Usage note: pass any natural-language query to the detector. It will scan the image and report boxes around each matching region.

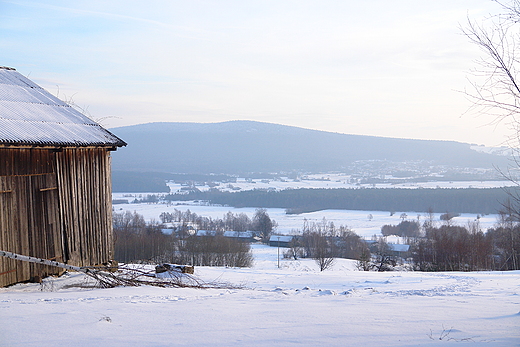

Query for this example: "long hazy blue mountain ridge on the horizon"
[111,121,507,174]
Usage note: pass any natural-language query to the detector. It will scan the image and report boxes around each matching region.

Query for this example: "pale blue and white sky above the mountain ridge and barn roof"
[0,0,507,146]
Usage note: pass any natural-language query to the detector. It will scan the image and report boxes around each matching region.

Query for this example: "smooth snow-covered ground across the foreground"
[0,245,520,347]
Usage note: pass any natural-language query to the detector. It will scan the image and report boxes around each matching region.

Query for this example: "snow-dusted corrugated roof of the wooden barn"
[0,67,126,147]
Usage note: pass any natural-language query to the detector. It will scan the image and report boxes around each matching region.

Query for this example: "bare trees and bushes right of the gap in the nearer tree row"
[284,212,520,271]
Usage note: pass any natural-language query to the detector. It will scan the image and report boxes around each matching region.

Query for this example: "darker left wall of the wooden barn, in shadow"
[0,149,63,286]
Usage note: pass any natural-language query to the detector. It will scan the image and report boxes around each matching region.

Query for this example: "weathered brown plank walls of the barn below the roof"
[0,148,113,286]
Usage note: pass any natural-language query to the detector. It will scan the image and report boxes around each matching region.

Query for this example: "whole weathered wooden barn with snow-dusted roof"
[0,67,126,287]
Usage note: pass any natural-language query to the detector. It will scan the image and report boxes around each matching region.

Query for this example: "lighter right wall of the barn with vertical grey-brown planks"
[56,148,114,266]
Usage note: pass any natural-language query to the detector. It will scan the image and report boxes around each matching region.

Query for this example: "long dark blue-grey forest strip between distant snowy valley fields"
[165,188,508,214]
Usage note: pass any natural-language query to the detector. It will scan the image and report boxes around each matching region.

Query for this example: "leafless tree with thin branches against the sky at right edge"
[463,0,520,269]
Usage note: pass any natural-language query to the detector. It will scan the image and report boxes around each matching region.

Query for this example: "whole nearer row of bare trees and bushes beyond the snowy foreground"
[114,209,520,271]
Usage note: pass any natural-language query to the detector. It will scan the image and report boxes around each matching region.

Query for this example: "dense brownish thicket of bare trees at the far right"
[379,212,520,271]
